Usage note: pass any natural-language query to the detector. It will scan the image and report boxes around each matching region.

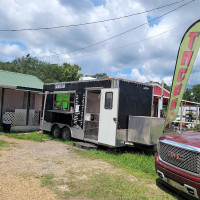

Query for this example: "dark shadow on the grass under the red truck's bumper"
[156,178,197,200]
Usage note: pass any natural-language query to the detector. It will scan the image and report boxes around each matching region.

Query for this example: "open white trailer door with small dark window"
[98,88,119,146]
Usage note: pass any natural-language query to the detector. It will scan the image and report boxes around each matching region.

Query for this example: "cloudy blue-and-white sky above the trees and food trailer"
[0,0,200,85]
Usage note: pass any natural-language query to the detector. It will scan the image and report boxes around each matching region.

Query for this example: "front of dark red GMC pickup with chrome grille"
[155,132,200,198]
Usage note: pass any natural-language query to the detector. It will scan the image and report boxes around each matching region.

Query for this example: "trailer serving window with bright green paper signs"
[54,93,74,110]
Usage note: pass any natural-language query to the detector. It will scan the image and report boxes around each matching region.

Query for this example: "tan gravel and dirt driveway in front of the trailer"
[0,135,138,200]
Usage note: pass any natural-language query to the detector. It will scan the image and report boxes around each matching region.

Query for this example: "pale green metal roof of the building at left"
[0,70,43,89]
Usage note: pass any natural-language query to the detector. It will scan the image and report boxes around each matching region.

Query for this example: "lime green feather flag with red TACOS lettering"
[165,20,200,126]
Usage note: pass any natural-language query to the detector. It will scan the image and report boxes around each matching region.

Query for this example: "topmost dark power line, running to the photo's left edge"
[0,0,185,32]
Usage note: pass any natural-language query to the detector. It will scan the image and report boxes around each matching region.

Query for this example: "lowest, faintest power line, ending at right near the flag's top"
[46,17,199,60]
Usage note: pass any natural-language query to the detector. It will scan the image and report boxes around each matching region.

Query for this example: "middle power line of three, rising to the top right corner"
[37,0,195,58]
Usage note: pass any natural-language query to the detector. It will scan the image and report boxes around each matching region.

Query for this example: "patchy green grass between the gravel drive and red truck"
[70,150,182,200]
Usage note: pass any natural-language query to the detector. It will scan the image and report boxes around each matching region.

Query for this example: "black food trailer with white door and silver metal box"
[43,79,164,147]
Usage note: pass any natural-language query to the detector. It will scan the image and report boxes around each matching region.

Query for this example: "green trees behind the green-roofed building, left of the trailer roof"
[0,57,82,83]
